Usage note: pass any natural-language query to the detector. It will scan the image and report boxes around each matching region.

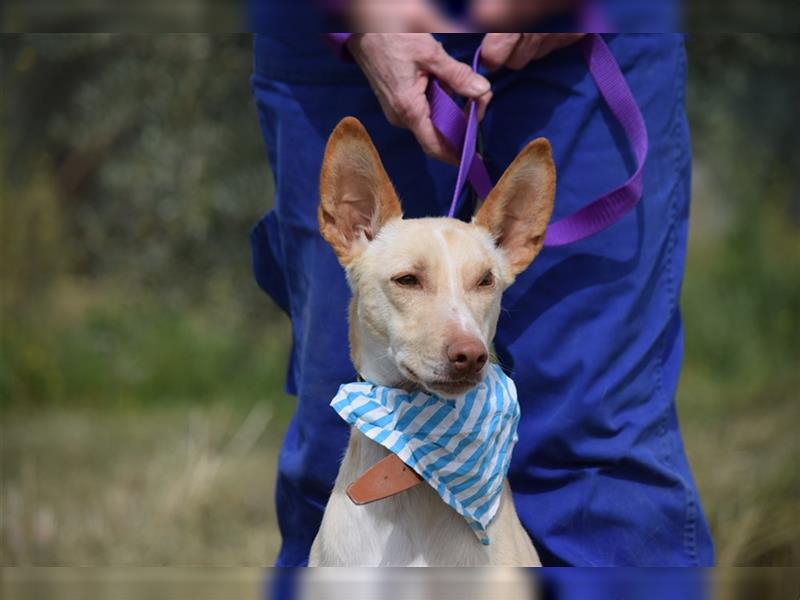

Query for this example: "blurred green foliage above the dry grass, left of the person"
[0,35,287,414]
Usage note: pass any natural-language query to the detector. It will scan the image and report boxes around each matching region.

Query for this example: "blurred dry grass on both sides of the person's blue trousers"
[0,392,800,566]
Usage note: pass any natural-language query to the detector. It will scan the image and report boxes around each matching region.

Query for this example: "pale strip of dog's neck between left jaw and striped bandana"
[349,294,417,391]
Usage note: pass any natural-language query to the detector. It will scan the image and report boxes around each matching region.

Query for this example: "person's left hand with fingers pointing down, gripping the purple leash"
[347,33,492,164]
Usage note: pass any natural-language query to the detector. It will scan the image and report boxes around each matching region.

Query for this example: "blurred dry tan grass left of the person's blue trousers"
[0,404,279,566]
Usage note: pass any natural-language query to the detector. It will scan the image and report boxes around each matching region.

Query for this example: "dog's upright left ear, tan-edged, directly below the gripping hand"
[317,117,402,266]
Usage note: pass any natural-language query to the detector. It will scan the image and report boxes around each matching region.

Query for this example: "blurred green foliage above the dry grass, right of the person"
[682,34,800,409]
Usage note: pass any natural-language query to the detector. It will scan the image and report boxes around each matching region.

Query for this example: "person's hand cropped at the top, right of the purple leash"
[481,33,584,71]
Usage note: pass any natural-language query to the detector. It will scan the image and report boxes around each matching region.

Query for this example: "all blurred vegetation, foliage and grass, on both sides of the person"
[0,35,800,565]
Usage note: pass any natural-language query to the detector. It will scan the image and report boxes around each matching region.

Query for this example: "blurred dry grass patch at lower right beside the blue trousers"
[681,394,800,566]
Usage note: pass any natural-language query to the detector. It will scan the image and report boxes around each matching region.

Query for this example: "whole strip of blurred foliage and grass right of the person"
[678,34,800,565]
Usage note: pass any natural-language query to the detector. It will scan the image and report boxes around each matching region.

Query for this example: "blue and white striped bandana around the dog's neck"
[331,364,519,544]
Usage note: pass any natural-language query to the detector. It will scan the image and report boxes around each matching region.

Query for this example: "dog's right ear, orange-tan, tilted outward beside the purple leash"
[473,138,556,275]
